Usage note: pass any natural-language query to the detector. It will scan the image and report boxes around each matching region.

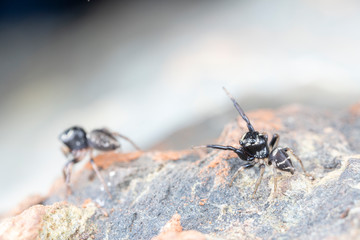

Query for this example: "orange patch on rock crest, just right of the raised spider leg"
[249,109,283,132]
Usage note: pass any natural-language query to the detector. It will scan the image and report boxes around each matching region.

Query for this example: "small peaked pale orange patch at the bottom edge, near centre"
[152,213,206,240]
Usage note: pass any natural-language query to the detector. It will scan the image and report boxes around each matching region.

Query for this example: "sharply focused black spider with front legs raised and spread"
[201,88,312,197]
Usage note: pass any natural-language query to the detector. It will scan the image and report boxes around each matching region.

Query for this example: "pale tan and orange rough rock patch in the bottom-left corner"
[0,201,96,240]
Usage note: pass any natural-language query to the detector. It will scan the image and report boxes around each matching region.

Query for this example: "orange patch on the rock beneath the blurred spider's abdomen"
[85,151,143,169]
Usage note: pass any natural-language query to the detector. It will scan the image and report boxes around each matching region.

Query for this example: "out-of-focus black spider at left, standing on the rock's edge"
[59,126,140,198]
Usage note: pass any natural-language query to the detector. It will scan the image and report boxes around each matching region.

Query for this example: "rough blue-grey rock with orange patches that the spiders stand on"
[0,105,360,239]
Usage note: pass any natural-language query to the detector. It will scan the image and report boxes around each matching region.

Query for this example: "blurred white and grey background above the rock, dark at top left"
[0,0,360,212]
